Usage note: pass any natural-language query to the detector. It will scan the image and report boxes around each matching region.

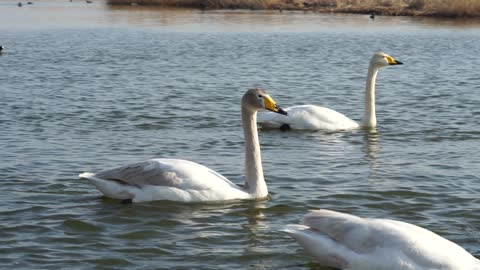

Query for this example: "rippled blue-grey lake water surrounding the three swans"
[0,1,480,269]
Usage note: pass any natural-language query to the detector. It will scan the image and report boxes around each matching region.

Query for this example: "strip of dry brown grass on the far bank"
[107,0,480,17]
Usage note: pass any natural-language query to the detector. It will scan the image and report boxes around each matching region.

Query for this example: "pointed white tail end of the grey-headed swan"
[78,172,132,200]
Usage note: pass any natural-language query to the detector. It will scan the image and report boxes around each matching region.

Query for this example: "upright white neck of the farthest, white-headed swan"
[362,64,378,128]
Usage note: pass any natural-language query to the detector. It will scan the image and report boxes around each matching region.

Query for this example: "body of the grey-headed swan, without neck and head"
[80,158,253,202]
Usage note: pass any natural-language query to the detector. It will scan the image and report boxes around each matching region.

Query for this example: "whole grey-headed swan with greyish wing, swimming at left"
[79,89,286,202]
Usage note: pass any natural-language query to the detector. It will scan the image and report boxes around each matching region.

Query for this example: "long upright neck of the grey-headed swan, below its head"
[242,107,268,198]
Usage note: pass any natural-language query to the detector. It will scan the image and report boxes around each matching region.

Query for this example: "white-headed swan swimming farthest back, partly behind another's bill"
[258,52,403,131]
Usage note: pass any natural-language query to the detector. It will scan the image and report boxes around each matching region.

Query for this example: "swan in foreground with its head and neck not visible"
[284,210,480,270]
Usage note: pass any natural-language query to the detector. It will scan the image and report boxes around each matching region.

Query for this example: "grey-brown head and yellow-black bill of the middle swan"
[242,88,287,115]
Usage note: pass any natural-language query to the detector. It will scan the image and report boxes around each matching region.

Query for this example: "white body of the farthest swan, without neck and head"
[258,105,359,131]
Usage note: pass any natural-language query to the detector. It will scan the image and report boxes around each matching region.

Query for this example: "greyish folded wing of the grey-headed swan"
[95,159,233,190]
